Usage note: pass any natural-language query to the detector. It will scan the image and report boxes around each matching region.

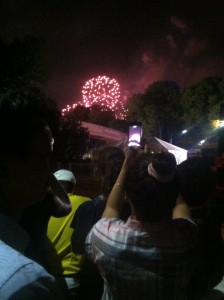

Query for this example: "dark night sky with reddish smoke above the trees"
[0,0,224,108]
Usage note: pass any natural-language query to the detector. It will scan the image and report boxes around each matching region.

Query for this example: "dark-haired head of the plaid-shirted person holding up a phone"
[124,152,179,222]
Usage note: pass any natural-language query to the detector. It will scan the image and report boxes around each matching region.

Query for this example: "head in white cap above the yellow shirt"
[54,169,76,194]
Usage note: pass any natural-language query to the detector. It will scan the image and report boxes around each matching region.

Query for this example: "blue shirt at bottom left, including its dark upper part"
[0,213,65,300]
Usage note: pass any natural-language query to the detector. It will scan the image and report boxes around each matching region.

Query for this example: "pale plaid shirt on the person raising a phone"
[86,218,197,300]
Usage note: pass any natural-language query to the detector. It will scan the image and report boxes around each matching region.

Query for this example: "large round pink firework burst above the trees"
[82,76,124,119]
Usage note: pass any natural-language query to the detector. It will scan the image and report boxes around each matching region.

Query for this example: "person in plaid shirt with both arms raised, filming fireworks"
[86,148,197,300]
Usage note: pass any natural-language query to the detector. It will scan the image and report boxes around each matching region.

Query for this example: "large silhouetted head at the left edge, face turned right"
[0,90,60,218]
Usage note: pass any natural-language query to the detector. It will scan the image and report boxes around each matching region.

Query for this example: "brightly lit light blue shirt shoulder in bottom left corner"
[0,241,64,299]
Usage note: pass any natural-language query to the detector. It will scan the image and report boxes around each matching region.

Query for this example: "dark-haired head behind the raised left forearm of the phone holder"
[94,146,125,198]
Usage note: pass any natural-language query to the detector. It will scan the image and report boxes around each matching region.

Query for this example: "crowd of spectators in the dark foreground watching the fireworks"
[0,92,224,300]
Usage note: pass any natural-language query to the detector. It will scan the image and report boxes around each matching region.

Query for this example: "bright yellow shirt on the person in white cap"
[47,194,90,276]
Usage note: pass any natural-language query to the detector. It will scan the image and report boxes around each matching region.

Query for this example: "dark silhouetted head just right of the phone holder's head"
[177,156,215,207]
